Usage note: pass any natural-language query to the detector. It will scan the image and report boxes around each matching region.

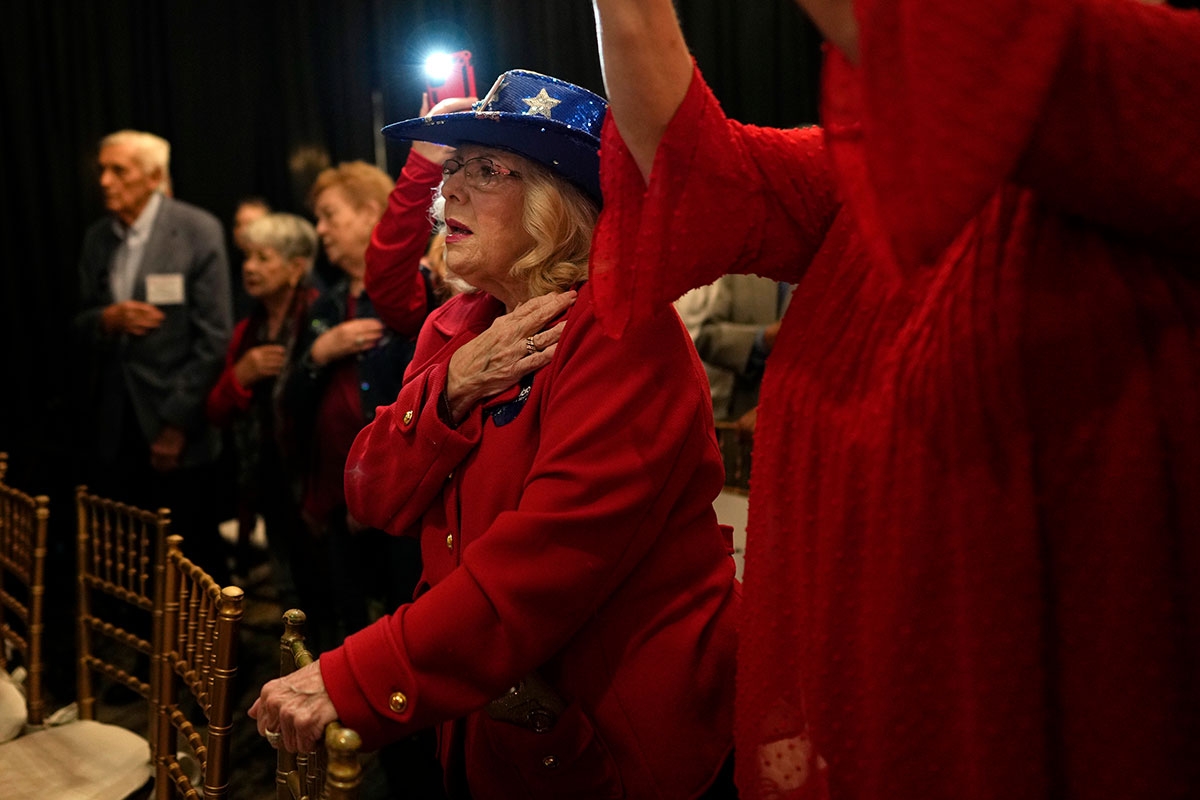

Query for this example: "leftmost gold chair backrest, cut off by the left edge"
[0,453,50,726]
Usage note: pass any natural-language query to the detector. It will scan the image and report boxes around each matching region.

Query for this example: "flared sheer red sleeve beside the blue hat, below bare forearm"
[589,63,838,336]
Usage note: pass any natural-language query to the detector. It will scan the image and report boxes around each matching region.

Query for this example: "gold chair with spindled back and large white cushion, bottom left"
[0,487,157,800]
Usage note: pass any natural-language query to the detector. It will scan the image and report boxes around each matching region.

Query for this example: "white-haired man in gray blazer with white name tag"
[74,131,233,575]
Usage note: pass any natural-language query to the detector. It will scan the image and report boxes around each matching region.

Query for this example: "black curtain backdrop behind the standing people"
[0,0,820,494]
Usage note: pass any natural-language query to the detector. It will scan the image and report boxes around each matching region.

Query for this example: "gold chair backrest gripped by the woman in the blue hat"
[275,608,362,800]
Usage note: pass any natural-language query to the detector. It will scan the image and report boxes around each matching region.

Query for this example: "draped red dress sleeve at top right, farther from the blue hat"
[822,0,1200,266]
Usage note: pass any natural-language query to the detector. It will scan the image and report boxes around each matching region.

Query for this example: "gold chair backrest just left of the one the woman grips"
[155,535,245,800]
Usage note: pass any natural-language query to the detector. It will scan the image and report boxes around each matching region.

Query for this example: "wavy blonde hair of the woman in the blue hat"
[431,154,600,297]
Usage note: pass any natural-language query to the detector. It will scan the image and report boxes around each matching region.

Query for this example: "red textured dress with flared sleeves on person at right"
[592,0,1200,800]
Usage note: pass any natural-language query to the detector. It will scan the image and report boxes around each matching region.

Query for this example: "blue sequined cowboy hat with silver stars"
[383,70,608,204]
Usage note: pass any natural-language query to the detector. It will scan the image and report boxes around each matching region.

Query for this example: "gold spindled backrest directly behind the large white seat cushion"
[76,486,170,734]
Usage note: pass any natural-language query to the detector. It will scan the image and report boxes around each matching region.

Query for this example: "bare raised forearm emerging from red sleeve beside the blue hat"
[593,0,692,178]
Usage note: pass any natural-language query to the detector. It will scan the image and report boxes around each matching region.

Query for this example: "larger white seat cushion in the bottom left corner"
[0,720,152,800]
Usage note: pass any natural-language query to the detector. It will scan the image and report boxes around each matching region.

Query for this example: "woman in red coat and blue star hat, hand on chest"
[251,71,739,800]
